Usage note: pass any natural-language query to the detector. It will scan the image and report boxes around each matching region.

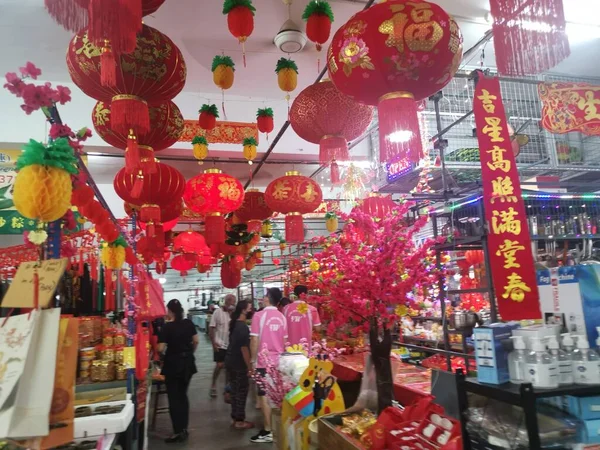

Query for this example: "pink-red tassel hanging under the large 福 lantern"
[377,92,423,162]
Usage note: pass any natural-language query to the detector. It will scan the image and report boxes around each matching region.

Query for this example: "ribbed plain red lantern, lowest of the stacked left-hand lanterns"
[113,163,185,237]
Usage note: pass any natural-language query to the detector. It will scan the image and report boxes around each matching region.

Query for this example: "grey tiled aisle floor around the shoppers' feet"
[148,335,262,450]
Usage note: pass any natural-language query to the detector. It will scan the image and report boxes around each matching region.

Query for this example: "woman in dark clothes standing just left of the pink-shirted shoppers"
[225,300,254,430]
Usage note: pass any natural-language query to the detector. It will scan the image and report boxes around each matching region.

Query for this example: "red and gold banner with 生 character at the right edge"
[538,83,600,136]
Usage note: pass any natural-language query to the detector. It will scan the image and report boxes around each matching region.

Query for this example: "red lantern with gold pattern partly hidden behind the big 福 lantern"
[290,80,373,179]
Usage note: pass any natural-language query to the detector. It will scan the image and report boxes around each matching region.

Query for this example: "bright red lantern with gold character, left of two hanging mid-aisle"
[183,169,244,246]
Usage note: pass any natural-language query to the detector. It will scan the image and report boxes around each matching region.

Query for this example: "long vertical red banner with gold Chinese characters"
[473,72,542,321]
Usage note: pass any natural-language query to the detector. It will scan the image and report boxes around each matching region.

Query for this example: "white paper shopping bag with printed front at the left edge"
[0,308,60,440]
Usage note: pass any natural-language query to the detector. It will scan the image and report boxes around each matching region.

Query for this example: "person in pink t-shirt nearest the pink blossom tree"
[283,285,321,350]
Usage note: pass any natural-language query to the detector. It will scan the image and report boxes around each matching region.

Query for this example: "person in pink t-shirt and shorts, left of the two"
[250,288,288,443]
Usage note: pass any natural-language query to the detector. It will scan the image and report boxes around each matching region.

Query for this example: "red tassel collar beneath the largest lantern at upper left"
[110,95,150,138]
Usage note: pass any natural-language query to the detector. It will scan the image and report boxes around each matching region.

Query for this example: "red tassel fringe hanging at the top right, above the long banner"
[490,0,571,76]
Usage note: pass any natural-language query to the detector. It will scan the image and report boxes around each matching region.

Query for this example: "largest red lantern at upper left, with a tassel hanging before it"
[67,25,186,141]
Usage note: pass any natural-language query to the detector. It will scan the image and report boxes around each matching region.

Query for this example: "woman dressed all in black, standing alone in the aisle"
[158,299,198,443]
